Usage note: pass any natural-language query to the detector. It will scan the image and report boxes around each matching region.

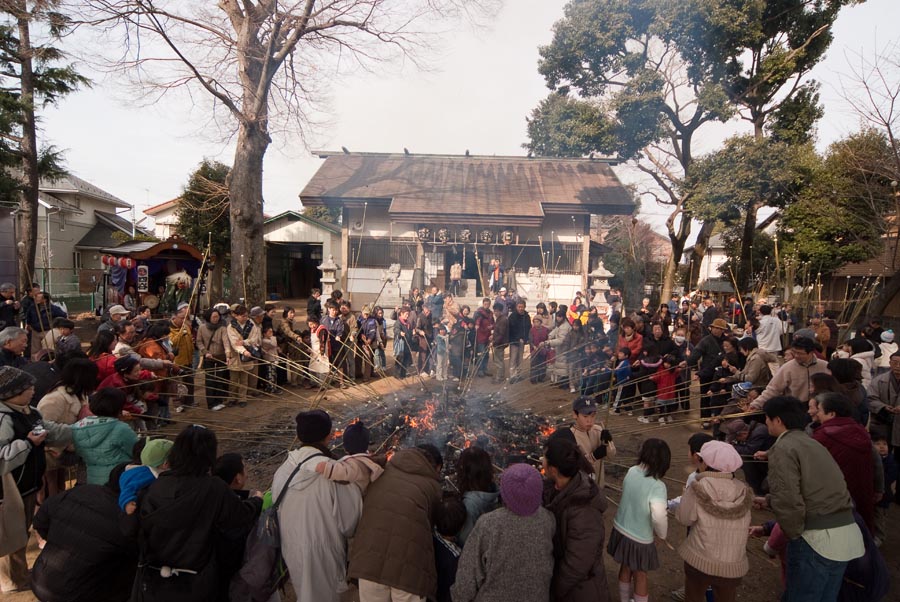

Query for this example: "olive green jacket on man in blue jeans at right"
[767,430,855,539]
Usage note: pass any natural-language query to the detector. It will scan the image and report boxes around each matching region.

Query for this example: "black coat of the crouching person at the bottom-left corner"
[31,485,138,602]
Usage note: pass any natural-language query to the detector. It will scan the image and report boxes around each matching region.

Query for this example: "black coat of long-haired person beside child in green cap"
[132,472,262,602]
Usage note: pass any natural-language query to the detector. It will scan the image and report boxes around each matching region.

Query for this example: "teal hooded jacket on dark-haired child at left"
[72,416,138,485]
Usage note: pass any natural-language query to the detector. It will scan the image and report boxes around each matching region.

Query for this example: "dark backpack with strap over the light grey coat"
[229,454,325,602]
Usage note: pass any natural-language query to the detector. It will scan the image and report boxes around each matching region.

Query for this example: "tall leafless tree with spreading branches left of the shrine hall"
[77,0,500,302]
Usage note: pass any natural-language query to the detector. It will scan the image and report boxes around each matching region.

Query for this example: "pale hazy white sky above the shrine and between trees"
[40,0,900,232]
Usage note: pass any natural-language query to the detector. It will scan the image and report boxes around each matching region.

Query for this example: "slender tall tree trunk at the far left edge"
[16,0,39,291]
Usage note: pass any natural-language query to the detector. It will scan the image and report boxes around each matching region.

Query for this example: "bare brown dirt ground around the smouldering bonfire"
[0,314,900,602]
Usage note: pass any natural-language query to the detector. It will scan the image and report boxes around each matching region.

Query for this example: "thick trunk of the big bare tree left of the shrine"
[227,122,271,307]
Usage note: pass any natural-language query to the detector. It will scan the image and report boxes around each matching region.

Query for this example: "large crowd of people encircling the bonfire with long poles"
[0,278,900,602]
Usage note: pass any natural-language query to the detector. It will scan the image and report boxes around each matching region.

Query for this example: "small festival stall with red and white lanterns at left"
[100,236,214,314]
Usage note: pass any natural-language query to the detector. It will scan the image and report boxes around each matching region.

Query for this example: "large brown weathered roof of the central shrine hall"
[300,152,635,225]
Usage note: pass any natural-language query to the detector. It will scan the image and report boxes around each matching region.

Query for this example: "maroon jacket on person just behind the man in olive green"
[813,417,875,531]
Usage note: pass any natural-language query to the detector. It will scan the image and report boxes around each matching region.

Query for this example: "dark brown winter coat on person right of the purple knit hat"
[547,472,609,602]
